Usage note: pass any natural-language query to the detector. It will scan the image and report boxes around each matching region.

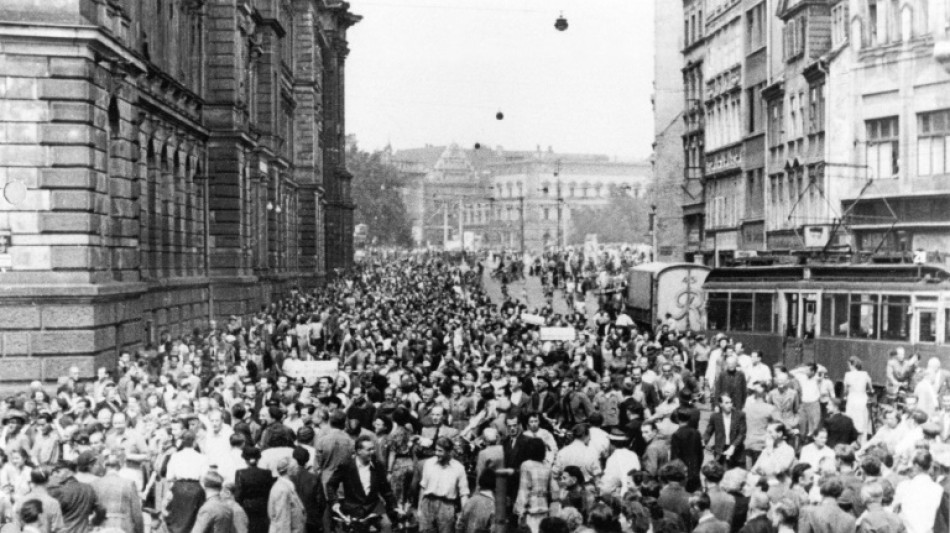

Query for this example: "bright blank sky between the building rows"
[346,0,653,159]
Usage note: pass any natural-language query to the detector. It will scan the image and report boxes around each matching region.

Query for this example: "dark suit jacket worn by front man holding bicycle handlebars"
[327,458,396,518]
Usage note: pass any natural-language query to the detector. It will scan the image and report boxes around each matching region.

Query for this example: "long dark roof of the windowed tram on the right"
[706,263,950,284]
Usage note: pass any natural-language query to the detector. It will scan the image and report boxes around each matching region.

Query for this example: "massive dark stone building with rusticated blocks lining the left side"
[0,0,359,381]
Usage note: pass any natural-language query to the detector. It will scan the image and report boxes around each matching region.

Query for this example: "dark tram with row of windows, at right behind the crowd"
[703,264,950,384]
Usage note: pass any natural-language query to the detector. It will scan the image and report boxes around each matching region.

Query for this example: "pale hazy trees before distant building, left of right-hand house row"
[570,187,650,244]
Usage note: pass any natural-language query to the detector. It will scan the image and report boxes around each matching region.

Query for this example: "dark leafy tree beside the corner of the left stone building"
[346,144,412,246]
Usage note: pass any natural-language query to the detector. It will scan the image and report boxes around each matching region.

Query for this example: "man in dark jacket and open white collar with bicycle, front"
[327,435,399,529]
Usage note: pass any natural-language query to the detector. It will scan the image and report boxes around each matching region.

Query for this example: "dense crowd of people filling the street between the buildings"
[0,254,950,533]
